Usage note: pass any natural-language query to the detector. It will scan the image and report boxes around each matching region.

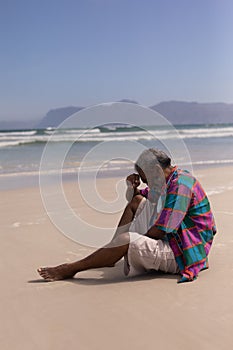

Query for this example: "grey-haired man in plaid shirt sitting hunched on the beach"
[38,149,216,282]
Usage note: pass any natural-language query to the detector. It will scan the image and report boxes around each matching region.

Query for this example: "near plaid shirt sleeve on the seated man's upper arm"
[155,178,193,233]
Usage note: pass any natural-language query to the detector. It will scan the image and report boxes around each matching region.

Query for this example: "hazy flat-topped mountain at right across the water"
[150,101,233,125]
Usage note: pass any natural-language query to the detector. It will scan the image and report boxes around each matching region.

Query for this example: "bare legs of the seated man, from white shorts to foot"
[37,196,143,281]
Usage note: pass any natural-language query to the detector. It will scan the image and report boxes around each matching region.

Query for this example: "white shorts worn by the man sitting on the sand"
[124,198,179,276]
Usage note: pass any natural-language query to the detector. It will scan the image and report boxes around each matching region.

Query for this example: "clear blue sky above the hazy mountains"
[0,0,233,120]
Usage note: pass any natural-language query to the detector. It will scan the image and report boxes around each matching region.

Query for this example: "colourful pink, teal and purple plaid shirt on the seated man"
[155,167,216,282]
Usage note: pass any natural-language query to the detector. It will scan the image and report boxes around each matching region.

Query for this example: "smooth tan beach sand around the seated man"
[0,167,233,350]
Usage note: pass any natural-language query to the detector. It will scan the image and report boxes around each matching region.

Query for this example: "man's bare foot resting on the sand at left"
[37,264,75,282]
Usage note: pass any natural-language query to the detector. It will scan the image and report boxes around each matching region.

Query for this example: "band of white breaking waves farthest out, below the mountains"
[0,125,233,148]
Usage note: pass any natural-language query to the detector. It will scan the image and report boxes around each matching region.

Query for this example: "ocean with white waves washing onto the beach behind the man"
[0,124,233,190]
